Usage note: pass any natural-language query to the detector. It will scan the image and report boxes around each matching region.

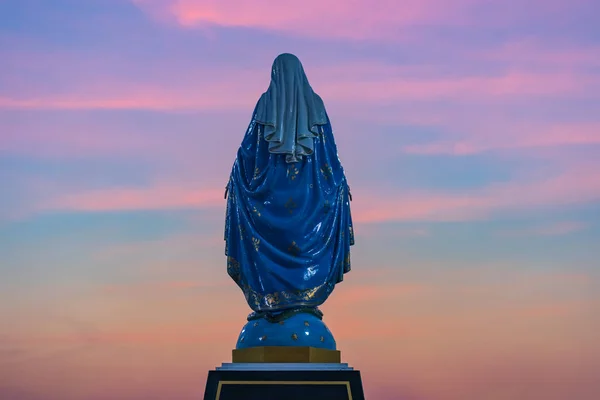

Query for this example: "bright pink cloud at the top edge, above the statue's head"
[132,0,472,39]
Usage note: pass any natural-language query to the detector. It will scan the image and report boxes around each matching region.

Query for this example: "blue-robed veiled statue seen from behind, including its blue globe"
[225,54,354,350]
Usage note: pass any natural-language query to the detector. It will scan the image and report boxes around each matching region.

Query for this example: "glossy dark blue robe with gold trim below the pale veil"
[225,103,354,312]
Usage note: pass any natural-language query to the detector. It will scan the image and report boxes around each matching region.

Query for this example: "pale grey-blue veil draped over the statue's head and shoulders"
[256,53,327,163]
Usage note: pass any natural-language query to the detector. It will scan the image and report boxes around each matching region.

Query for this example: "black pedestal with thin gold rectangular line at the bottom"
[204,369,365,400]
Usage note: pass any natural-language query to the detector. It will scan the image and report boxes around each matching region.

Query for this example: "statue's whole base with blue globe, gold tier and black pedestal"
[204,313,364,400]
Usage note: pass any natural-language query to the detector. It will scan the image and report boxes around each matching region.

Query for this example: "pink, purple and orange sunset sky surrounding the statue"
[0,0,600,400]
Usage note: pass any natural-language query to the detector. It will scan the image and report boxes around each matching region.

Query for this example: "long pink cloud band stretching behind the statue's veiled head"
[0,65,600,111]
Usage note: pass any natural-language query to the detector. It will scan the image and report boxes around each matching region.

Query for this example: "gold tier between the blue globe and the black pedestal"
[232,346,342,363]
